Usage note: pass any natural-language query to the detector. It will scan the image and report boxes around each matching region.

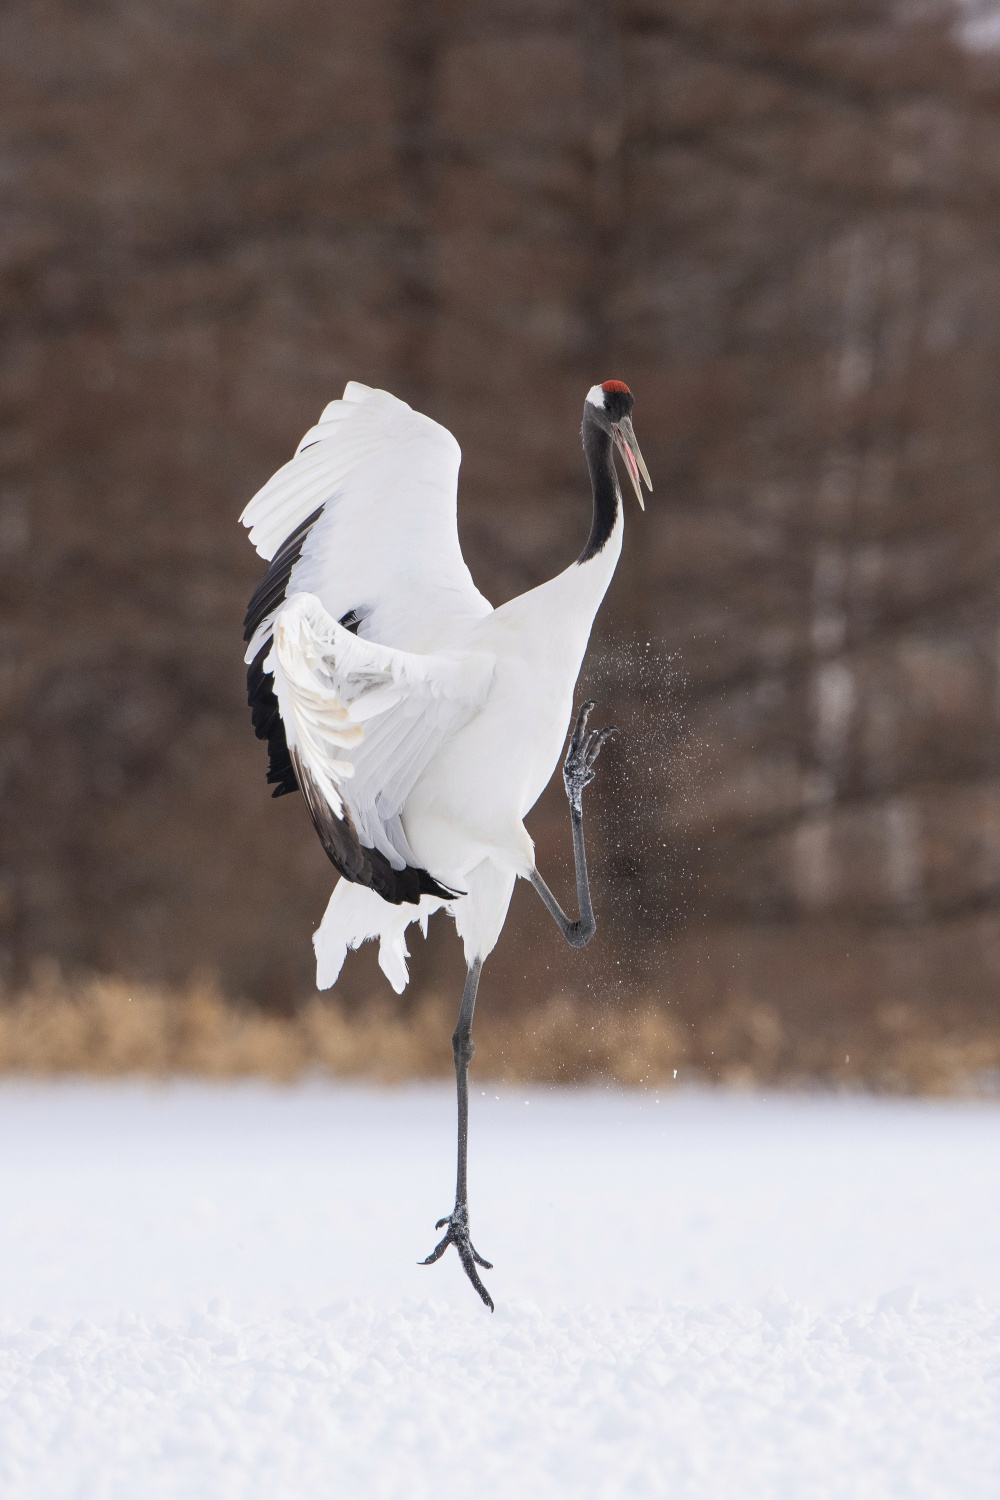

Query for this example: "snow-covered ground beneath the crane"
[0,1085,1000,1500]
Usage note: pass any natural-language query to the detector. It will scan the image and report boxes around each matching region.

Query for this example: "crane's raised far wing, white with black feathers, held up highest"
[241,381,492,816]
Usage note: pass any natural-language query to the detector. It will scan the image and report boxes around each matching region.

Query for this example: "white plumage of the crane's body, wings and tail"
[241,381,622,993]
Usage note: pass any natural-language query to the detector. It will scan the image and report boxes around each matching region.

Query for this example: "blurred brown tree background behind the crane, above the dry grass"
[0,0,1000,1046]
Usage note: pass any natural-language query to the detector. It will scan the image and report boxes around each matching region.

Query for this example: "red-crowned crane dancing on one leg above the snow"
[241,380,652,1310]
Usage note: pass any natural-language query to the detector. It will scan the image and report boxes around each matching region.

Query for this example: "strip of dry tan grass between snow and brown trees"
[0,966,1000,1094]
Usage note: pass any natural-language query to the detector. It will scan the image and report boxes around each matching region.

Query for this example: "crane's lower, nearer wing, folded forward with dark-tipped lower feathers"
[271,593,493,905]
